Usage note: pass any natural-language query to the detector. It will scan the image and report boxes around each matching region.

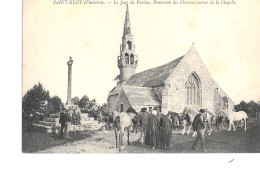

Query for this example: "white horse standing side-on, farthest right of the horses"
[219,109,248,131]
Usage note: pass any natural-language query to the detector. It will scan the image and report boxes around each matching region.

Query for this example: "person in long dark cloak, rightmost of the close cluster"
[161,114,172,150]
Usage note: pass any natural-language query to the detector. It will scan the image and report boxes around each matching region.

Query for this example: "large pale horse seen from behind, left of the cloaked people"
[113,110,137,151]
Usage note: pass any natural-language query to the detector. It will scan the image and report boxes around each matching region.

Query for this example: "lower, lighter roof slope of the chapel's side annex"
[123,86,161,106]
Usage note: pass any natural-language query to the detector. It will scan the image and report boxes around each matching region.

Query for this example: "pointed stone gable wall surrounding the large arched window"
[162,49,217,112]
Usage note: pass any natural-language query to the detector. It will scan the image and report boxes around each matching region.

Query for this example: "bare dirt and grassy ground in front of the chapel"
[22,119,260,153]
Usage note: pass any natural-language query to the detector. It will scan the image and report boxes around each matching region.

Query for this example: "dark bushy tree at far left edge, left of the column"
[22,82,50,115]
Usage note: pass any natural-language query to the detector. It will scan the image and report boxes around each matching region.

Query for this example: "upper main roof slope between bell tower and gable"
[124,56,184,87]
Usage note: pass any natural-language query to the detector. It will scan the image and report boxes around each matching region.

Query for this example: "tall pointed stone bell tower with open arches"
[117,5,138,83]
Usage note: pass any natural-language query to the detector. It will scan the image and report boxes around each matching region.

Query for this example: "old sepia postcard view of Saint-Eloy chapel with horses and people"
[20,0,260,154]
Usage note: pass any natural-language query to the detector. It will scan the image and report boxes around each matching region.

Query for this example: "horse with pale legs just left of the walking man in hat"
[181,107,198,136]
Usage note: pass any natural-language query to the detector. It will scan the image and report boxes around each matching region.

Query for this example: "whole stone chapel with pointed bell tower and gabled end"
[107,6,234,113]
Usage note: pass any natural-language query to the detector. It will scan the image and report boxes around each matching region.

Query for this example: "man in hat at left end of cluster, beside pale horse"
[139,108,149,144]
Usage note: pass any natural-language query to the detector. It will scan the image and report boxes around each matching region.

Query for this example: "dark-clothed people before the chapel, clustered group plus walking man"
[138,108,207,152]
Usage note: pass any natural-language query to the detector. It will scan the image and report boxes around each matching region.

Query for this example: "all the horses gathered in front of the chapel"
[108,107,248,151]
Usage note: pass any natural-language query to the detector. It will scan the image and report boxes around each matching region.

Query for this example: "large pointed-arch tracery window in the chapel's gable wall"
[185,73,202,106]
